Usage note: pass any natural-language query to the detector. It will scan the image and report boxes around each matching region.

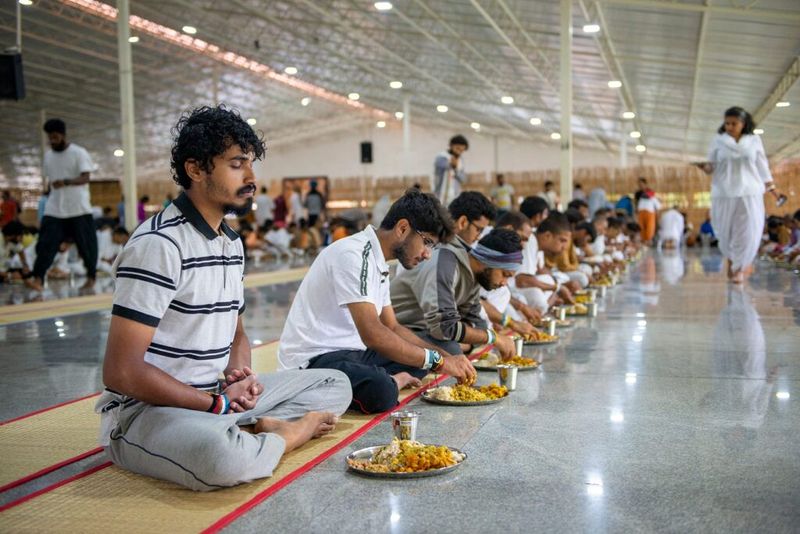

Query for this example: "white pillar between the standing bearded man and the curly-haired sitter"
[117,0,139,232]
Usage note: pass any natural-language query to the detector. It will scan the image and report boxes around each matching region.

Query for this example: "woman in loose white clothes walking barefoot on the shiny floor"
[698,107,780,284]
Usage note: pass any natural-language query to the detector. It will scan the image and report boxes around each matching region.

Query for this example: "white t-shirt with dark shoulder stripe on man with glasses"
[278,226,392,369]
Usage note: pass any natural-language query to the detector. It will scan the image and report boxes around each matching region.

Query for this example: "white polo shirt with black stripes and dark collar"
[112,193,244,388]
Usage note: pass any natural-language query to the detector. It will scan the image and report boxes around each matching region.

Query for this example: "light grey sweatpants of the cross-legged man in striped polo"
[106,369,352,491]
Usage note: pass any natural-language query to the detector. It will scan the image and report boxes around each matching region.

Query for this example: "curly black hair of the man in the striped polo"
[170,105,267,189]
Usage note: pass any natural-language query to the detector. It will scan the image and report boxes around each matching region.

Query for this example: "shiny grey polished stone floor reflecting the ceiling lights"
[0,251,800,532]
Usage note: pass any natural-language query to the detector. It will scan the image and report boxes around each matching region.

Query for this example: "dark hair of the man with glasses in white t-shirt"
[381,187,453,242]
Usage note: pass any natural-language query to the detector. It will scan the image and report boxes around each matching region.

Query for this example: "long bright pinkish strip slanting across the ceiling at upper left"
[63,0,389,118]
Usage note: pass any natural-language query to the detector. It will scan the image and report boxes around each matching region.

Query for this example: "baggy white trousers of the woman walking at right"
[711,195,764,272]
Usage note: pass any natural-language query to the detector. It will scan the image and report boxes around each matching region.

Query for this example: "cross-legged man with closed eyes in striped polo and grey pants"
[97,106,351,491]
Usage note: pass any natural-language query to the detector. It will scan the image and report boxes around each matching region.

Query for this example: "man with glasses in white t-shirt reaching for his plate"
[278,189,475,413]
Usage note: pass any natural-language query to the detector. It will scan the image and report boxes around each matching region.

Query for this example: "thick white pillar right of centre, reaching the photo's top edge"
[559,0,572,205]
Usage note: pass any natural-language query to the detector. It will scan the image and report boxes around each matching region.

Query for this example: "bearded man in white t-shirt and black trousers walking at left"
[25,119,97,291]
